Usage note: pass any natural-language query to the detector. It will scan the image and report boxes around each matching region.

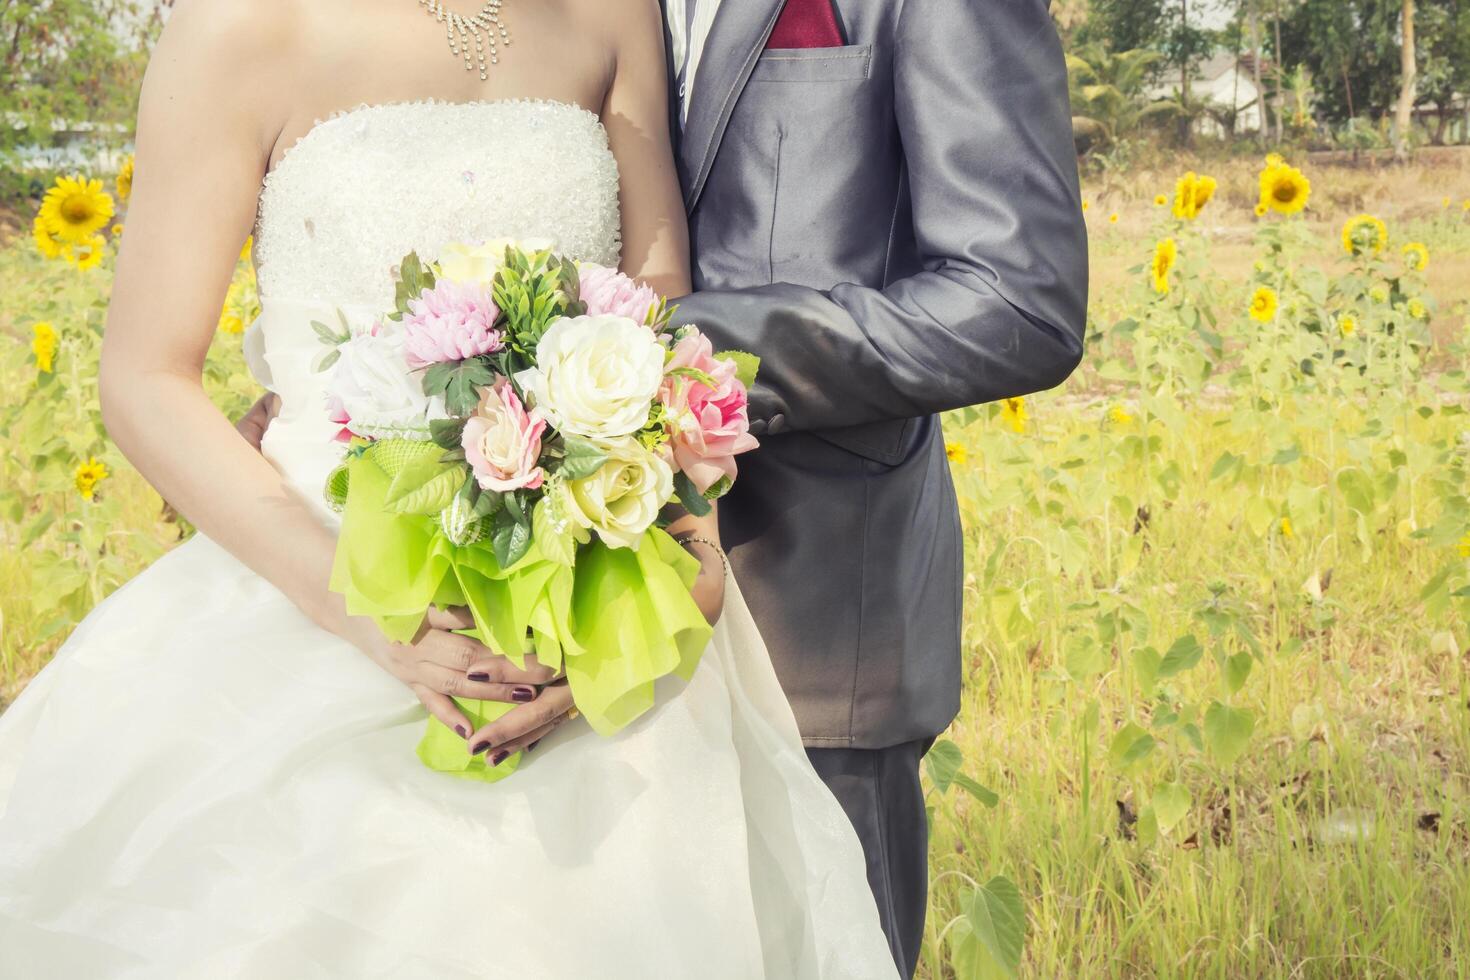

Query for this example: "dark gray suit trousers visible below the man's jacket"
[807,739,933,979]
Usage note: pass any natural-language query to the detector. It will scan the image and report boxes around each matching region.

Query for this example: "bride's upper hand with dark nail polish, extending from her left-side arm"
[348,608,564,738]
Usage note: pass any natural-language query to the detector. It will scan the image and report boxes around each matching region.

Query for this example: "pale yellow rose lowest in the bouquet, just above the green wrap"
[566,436,673,550]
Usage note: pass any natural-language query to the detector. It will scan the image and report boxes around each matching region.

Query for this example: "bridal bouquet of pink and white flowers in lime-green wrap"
[313,242,757,780]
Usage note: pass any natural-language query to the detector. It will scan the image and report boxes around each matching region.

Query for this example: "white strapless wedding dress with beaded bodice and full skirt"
[0,101,895,980]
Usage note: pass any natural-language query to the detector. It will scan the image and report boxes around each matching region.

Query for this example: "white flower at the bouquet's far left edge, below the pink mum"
[326,323,447,439]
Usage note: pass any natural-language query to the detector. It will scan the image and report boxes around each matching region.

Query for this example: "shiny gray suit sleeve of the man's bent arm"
[678,0,1088,432]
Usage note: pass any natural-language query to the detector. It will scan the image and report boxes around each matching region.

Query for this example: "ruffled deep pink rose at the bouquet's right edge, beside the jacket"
[659,331,760,494]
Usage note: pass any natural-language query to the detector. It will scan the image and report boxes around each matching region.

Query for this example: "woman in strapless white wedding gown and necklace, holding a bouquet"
[0,0,894,980]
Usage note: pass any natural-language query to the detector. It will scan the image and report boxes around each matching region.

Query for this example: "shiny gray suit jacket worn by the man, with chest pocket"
[667,0,1088,748]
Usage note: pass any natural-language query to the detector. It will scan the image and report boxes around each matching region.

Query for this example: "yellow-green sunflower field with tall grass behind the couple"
[0,149,1470,980]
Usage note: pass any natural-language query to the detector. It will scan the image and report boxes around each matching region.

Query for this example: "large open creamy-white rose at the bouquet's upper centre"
[516,316,664,439]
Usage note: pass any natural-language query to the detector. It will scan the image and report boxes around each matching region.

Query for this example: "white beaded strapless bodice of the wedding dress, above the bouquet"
[256,100,622,302]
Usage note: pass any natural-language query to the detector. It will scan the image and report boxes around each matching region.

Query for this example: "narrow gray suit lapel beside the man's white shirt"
[669,0,785,212]
